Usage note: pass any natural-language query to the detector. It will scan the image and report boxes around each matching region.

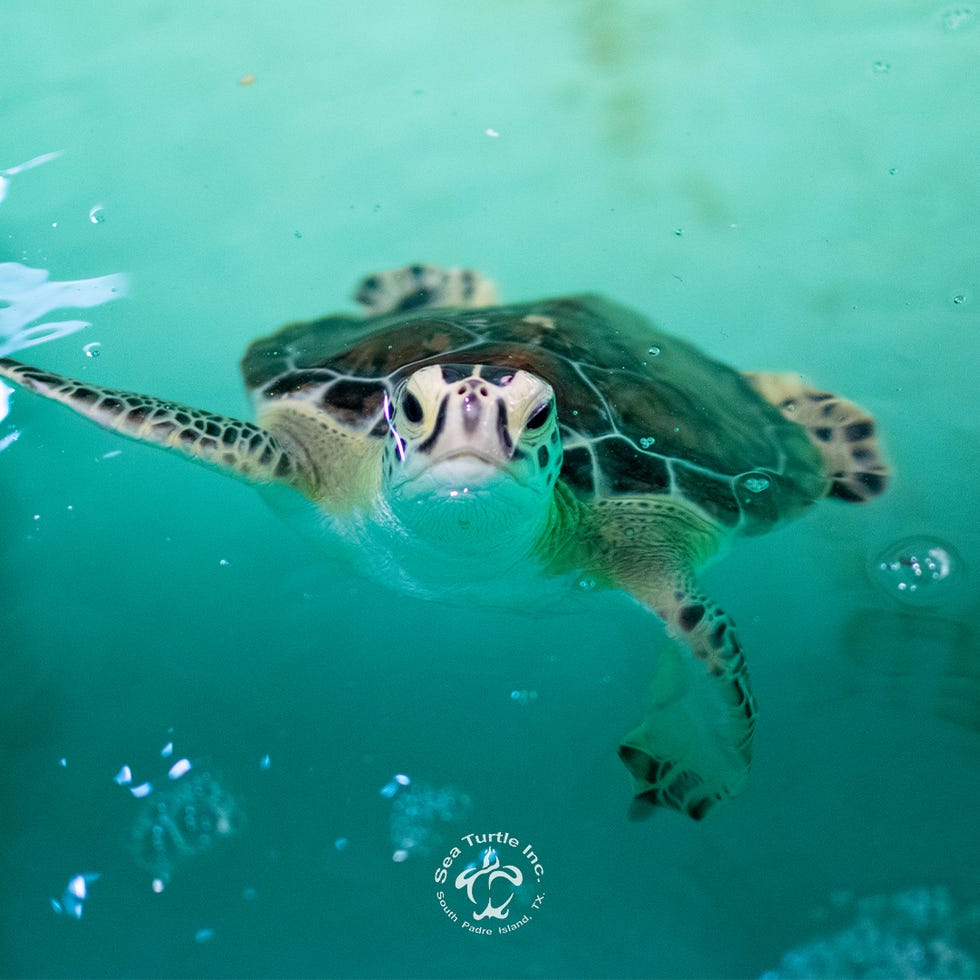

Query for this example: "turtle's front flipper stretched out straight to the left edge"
[0,358,314,496]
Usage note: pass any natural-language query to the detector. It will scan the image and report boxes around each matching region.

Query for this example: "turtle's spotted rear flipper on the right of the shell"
[744,371,889,504]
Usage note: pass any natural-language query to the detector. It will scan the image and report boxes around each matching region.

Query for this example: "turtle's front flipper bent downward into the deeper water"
[586,498,756,820]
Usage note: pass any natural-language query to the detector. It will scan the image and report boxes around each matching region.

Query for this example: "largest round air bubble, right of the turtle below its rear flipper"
[871,537,964,606]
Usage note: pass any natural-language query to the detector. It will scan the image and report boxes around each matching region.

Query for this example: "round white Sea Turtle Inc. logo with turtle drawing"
[434,831,544,936]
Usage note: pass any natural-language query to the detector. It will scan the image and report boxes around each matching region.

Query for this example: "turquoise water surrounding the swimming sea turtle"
[0,0,980,977]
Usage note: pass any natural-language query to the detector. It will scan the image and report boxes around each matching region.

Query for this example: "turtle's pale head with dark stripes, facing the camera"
[384,364,562,545]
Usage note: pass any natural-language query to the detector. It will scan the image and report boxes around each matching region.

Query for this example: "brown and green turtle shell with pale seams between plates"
[242,295,827,533]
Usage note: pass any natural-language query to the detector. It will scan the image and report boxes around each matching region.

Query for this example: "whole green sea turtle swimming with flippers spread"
[0,265,887,819]
